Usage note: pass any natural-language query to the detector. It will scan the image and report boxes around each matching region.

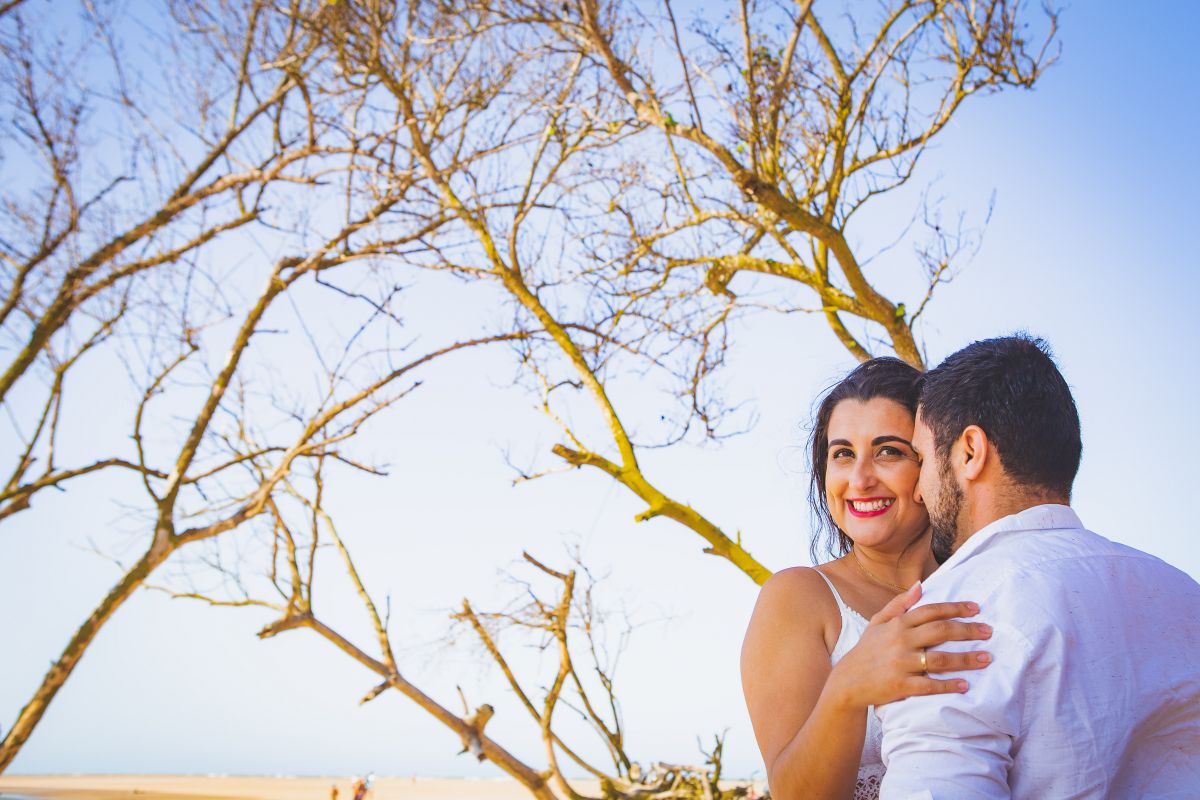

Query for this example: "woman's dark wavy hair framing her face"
[809,356,922,564]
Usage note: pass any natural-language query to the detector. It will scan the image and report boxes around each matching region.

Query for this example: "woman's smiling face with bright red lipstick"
[826,397,929,549]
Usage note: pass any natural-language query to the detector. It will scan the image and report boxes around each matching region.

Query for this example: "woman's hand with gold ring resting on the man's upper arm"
[827,583,991,708]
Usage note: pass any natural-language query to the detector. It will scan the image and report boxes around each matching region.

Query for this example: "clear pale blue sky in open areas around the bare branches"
[0,0,1200,776]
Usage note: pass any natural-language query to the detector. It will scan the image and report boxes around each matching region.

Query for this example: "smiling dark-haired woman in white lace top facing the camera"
[742,359,991,800]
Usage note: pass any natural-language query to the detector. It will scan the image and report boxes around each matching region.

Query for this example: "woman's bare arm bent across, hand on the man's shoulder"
[742,567,990,800]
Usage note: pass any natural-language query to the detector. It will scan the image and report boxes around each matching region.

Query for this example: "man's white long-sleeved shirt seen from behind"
[876,505,1200,800]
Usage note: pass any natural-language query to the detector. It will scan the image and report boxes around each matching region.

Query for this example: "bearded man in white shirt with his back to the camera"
[878,336,1200,800]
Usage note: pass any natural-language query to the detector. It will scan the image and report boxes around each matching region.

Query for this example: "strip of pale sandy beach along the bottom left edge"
[0,775,609,800]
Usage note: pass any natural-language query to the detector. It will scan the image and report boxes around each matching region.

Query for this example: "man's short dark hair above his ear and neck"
[920,333,1082,497]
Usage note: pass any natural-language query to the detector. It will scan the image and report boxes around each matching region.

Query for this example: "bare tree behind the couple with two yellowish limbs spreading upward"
[297,0,1055,594]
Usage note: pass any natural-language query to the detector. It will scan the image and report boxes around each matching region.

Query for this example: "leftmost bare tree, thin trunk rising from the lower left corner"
[0,2,524,770]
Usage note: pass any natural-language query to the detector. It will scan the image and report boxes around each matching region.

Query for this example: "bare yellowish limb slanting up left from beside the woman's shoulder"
[302,4,770,582]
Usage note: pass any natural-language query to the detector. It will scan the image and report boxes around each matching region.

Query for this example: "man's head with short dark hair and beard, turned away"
[913,335,1082,559]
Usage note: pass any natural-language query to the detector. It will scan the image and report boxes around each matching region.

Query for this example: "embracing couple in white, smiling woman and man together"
[742,336,1200,800]
